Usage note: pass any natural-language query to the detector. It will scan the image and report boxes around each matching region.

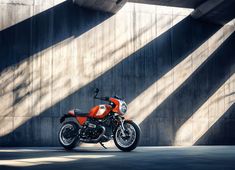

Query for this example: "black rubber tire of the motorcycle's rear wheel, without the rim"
[58,121,79,150]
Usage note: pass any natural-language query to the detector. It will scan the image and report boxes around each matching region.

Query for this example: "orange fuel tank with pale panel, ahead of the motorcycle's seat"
[88,105,112,119]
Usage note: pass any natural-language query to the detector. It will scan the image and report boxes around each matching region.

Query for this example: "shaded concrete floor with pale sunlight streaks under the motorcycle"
[0,146,235,170]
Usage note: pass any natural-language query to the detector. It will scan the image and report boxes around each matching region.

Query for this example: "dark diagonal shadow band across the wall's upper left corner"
[0,0,111,72]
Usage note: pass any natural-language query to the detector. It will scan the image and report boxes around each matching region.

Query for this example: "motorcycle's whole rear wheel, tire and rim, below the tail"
[58,121,79,150]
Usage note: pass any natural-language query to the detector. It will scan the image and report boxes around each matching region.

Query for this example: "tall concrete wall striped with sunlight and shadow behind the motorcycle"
[0,0,235,146]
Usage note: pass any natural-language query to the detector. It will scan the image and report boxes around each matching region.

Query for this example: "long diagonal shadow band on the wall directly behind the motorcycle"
[0,16,221,146]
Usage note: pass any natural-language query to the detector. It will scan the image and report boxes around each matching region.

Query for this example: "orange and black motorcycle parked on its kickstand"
[58,88,140,152]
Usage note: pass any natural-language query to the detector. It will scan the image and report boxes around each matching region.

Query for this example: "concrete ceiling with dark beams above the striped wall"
[73,0,235,25]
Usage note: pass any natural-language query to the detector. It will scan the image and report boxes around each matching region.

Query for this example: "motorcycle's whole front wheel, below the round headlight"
[114,121,140,152]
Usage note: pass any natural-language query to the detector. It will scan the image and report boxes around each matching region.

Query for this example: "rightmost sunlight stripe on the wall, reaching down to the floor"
[175,74,235,146]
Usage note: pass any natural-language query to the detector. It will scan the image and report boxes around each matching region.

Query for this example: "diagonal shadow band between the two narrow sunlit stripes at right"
[140,33,235,145]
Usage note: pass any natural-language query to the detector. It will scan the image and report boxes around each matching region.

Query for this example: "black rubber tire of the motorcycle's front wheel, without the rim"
[114,120,141,152]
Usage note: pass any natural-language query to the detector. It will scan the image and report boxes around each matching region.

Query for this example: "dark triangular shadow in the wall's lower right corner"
[195,104,235,145]
